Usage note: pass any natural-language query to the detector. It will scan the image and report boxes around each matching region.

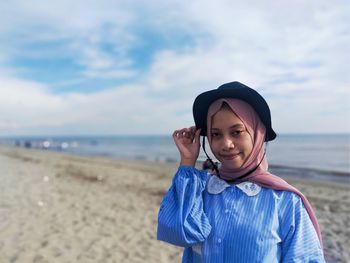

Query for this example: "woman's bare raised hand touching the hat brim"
[173,126,200,167]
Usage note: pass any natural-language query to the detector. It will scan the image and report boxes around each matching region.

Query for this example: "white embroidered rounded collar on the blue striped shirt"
[207,175,261,196]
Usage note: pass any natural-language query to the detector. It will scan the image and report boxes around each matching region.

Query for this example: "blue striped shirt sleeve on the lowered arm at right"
[281,193,325,263]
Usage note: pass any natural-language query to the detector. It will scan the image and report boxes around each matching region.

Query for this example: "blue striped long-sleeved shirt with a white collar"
[157,166,325,263]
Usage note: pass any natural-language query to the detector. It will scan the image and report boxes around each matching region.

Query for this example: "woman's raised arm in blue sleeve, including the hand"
[157,127,211,247]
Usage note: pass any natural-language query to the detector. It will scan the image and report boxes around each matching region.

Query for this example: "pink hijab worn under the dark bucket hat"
[207,99,323,248]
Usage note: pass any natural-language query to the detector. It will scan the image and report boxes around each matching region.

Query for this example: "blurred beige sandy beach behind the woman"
[0,146,350,263]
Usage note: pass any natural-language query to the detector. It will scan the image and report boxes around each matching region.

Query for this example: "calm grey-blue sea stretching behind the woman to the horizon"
[0,134,350,183]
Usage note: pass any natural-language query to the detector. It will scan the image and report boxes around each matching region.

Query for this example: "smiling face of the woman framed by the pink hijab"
[210,108,253,169]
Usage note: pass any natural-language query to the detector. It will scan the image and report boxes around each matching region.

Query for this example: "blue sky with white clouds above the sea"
[0,0,350,136]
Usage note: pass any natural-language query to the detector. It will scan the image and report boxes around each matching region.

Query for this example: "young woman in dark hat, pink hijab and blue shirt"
[157,82,324,263]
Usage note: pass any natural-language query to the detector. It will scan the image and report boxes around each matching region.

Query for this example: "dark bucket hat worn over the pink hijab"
[193,81,276,141]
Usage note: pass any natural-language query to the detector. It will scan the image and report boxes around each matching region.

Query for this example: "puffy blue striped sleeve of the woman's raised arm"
[157,166,211,247]
